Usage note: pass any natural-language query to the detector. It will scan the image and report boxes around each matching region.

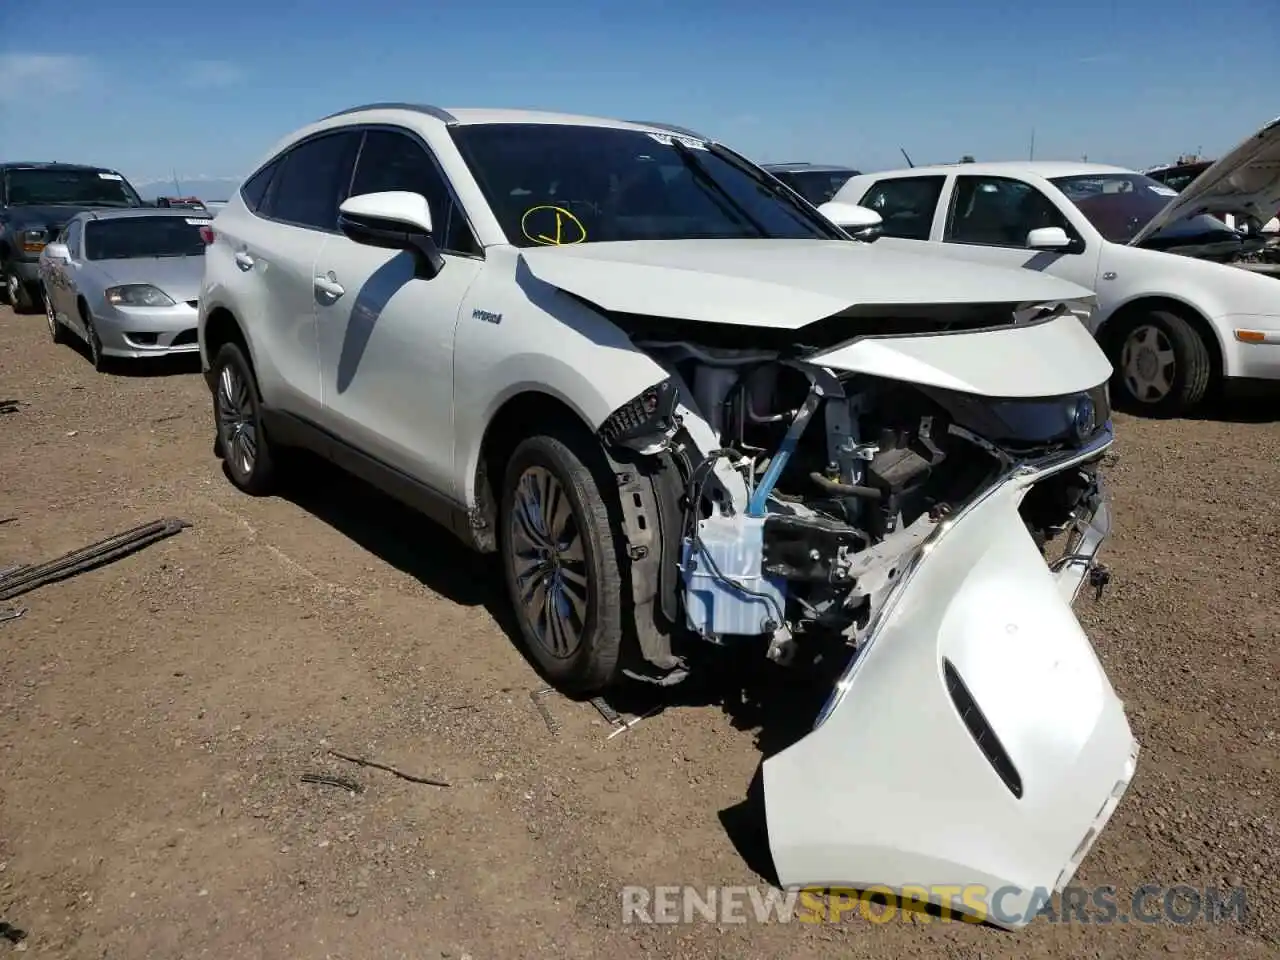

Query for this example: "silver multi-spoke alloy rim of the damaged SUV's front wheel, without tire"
[508,466,590,659]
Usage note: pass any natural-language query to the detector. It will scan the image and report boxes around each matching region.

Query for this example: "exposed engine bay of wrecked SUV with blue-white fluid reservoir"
[600,312,1110,680]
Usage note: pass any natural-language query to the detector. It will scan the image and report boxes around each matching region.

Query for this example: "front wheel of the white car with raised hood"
[1111,310,1213,416]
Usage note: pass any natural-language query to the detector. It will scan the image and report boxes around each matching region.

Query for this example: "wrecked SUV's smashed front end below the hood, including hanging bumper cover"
[600,305,1138,927]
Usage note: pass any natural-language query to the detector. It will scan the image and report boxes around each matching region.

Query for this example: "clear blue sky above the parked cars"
[0,0,1280,193]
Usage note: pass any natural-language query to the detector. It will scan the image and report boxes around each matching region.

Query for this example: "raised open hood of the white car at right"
[1129,118,1280,247]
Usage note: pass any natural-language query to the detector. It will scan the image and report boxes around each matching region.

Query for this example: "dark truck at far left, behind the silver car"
[0,163,143,312]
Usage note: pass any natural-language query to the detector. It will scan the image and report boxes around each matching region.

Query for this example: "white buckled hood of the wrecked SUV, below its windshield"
[520,239,1093,330]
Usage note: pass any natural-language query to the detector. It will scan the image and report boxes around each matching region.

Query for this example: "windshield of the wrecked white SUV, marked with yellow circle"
[451,123,847,247]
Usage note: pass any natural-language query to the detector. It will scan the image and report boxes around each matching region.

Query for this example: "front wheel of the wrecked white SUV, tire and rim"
[499,431,623,695]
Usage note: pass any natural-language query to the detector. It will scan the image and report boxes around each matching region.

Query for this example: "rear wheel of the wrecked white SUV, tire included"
[212,343,276,497]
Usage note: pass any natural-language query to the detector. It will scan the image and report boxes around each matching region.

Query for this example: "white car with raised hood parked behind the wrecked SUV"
[820,119,1280,416]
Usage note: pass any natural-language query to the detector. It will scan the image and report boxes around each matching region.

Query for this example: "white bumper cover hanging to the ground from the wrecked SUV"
[764,431,1138,928]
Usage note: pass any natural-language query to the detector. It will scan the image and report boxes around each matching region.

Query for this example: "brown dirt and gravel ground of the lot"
[0,302,1280,960]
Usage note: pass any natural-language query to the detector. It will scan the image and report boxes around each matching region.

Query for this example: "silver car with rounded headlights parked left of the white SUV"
[40,207,211,370]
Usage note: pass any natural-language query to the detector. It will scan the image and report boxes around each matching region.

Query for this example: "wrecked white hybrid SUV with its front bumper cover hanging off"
[200,104,1138,925]
